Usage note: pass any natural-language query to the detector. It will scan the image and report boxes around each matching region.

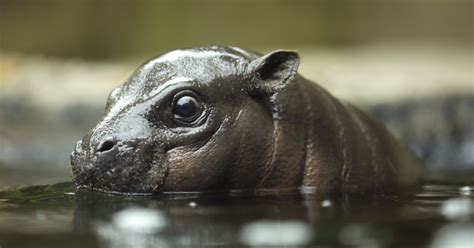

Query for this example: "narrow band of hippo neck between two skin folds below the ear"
[258,78,307,189]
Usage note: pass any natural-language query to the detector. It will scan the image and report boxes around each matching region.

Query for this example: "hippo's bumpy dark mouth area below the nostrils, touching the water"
[71,141,166,194]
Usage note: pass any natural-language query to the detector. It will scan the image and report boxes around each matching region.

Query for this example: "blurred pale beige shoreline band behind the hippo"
[0,43,474,106]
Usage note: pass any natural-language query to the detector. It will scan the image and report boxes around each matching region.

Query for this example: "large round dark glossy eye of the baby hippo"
[173,94,202,123]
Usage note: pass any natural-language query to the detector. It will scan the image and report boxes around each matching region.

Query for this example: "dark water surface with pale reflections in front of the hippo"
[0,183,474,248]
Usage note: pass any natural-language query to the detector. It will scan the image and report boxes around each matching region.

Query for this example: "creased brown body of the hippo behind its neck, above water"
[298,79,419,192]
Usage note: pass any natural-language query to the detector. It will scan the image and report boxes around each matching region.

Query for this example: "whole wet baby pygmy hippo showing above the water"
[71,46,422,193]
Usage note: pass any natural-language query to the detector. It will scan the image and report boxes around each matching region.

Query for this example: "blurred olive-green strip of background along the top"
[0,0,473,60]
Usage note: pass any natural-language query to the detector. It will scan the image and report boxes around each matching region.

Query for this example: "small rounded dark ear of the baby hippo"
[248,50,300,95]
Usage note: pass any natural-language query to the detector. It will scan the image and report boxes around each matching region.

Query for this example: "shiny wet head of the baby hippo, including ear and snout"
[71,47,299,193]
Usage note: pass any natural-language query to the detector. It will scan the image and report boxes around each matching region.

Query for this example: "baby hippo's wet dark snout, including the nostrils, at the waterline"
[71,134,161,193]
